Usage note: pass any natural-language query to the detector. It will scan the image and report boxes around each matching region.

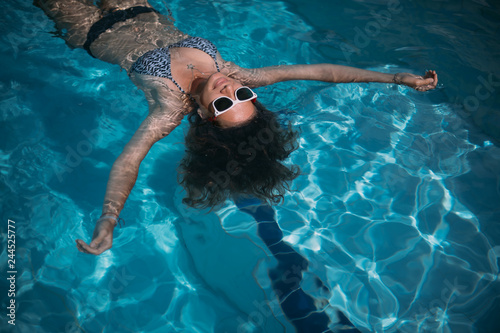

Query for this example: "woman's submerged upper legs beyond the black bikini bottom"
[33,0,102,48]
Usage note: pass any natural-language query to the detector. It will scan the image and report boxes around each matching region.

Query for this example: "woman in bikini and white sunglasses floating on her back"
[35,0,438,255]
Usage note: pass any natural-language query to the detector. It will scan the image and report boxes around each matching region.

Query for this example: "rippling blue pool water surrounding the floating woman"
[0,0,500,333]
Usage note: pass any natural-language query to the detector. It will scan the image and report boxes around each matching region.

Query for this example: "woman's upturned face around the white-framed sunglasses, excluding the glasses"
[198,73,257,127]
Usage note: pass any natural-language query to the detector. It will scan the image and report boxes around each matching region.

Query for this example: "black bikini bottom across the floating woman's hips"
[83,6,158,58]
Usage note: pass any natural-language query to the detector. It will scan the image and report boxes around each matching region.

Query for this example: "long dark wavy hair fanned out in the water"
[178,102,300,208]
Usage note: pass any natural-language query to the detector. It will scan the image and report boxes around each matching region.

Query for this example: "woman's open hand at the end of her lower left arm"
[76,217,116,255]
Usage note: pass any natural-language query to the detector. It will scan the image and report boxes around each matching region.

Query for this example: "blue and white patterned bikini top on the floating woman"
[130,37,220,94]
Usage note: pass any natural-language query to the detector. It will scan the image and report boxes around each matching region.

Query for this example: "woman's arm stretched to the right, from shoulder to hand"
[224,62,438,91]
